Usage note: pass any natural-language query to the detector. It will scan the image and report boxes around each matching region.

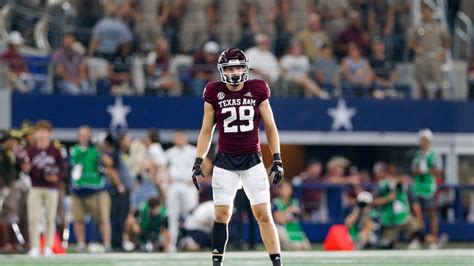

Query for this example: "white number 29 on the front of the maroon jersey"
[222,106,255,133]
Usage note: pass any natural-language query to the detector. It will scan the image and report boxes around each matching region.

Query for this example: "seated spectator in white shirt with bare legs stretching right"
[280,42,329,100]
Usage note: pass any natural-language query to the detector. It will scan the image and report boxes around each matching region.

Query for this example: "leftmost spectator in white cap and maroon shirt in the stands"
[1,31,35,93]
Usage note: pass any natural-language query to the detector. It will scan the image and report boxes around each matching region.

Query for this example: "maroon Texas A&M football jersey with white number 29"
[203,79,270,154]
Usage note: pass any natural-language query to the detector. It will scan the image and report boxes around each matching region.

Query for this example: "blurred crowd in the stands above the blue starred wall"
[0,0,474,99]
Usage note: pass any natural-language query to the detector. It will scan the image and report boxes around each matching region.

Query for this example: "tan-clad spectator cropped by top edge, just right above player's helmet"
[246,0,278,48]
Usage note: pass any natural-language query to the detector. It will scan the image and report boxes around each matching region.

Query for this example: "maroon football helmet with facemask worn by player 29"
[217,48,249,85]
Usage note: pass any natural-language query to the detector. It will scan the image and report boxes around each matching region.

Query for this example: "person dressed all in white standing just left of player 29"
[165,131,199,252]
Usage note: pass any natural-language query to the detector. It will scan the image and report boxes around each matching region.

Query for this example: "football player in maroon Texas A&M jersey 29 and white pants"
[192,48,283,265]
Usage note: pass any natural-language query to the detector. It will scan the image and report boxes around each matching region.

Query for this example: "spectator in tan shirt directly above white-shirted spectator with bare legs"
[295,13,332,62]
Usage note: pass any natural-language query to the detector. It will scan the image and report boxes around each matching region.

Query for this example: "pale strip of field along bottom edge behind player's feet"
[0,249,474,266]
